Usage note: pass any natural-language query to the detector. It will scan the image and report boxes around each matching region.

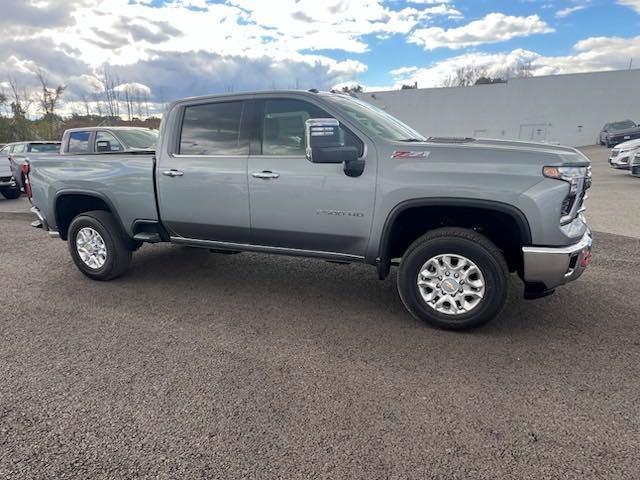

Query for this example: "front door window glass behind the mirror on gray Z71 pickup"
[261,99,363,156]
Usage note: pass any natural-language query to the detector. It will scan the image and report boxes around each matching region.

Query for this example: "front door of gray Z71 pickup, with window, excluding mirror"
[248,98,377,256]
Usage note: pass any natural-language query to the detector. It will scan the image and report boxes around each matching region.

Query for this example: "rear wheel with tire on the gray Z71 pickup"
[68,210,131,280]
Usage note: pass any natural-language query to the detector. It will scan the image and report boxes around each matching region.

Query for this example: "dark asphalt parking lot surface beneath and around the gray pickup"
[0,147,640,480]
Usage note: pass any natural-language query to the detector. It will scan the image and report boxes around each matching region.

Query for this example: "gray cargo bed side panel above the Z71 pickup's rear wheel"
[28,152,158,234]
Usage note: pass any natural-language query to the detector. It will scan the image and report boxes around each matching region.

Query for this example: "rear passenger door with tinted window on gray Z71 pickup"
[156,101,249,243]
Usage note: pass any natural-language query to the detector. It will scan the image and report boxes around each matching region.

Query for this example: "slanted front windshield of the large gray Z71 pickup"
[325,94,426,142]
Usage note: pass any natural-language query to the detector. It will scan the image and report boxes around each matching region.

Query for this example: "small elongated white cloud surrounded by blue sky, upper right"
[409,13,554,50]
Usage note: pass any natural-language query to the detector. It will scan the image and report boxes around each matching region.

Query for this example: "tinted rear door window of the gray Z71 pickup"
[180,102,249,155]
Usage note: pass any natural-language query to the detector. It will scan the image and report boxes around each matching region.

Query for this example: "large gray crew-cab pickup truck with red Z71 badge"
[24,91,592,329]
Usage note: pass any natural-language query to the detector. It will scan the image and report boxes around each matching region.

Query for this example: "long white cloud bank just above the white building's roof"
[390,36,640,88]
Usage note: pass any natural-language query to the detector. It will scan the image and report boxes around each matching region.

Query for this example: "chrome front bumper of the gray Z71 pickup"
[522,230,593,290]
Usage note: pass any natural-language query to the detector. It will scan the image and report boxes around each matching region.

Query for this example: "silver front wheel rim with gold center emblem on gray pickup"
[418,253,486,315]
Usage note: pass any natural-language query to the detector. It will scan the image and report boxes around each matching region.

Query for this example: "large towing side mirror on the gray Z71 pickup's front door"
[305,118,364,177]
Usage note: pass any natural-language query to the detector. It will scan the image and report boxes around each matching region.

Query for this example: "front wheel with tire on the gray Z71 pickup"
[398,227,509,330]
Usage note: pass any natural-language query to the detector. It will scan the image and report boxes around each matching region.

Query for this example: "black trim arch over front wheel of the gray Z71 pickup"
[376,197,531,280]
